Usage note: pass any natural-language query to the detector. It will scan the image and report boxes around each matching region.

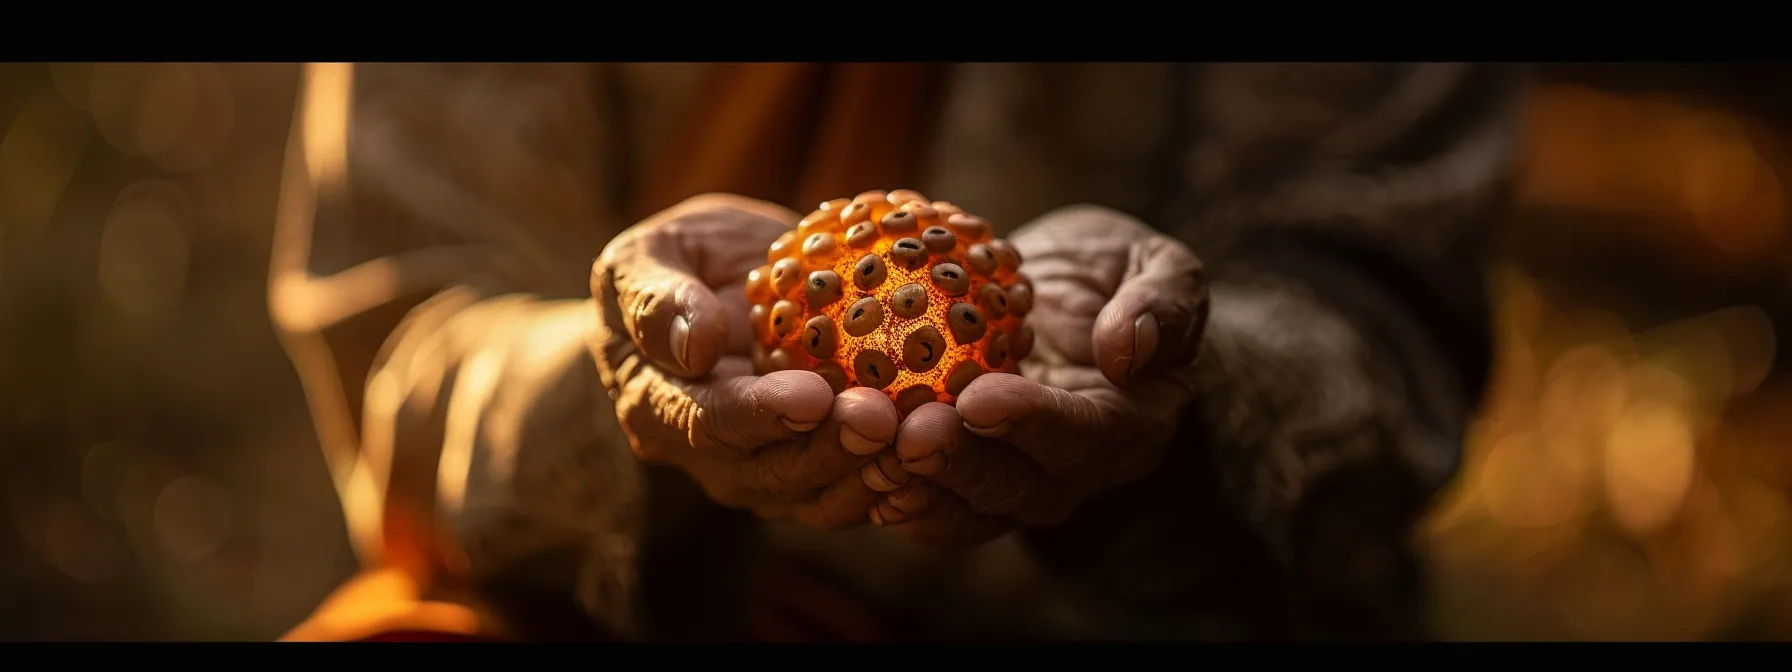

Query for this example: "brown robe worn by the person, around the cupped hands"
[271,63,1521,638]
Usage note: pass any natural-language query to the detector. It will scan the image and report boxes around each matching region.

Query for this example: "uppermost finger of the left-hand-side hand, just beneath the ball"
[677,369,833,455]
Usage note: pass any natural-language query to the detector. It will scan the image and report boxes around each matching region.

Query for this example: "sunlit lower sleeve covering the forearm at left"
[356,290,643,633]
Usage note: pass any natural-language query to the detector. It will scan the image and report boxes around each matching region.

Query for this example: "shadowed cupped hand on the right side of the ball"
[864,206,1208,547]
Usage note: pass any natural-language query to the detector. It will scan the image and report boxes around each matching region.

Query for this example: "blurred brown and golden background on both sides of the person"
[0,65,1792,640]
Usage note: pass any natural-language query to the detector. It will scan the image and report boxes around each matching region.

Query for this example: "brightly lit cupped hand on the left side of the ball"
[591,195,898,529]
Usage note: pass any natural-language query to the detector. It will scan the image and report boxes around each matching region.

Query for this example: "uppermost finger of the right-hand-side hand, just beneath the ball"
[959,373,1122,473]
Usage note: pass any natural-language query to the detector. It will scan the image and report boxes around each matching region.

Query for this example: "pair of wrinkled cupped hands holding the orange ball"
[591,195,1206,547]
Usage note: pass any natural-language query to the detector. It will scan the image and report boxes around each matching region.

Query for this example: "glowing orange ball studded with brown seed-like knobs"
[745,190,1032,414]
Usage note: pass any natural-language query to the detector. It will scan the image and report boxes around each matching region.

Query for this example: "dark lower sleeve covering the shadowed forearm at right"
[1186,250,1480,636]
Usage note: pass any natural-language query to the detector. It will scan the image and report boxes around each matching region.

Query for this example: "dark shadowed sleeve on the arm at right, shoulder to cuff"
[1185,63,1525,633]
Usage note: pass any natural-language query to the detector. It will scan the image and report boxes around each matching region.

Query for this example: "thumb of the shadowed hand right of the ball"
[1091,235,1208,387]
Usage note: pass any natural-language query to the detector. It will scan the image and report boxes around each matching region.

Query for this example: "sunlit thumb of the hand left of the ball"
[593,228,729,378]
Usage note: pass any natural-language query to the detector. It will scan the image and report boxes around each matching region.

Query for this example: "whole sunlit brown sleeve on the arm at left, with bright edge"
[269,65,638,637]
